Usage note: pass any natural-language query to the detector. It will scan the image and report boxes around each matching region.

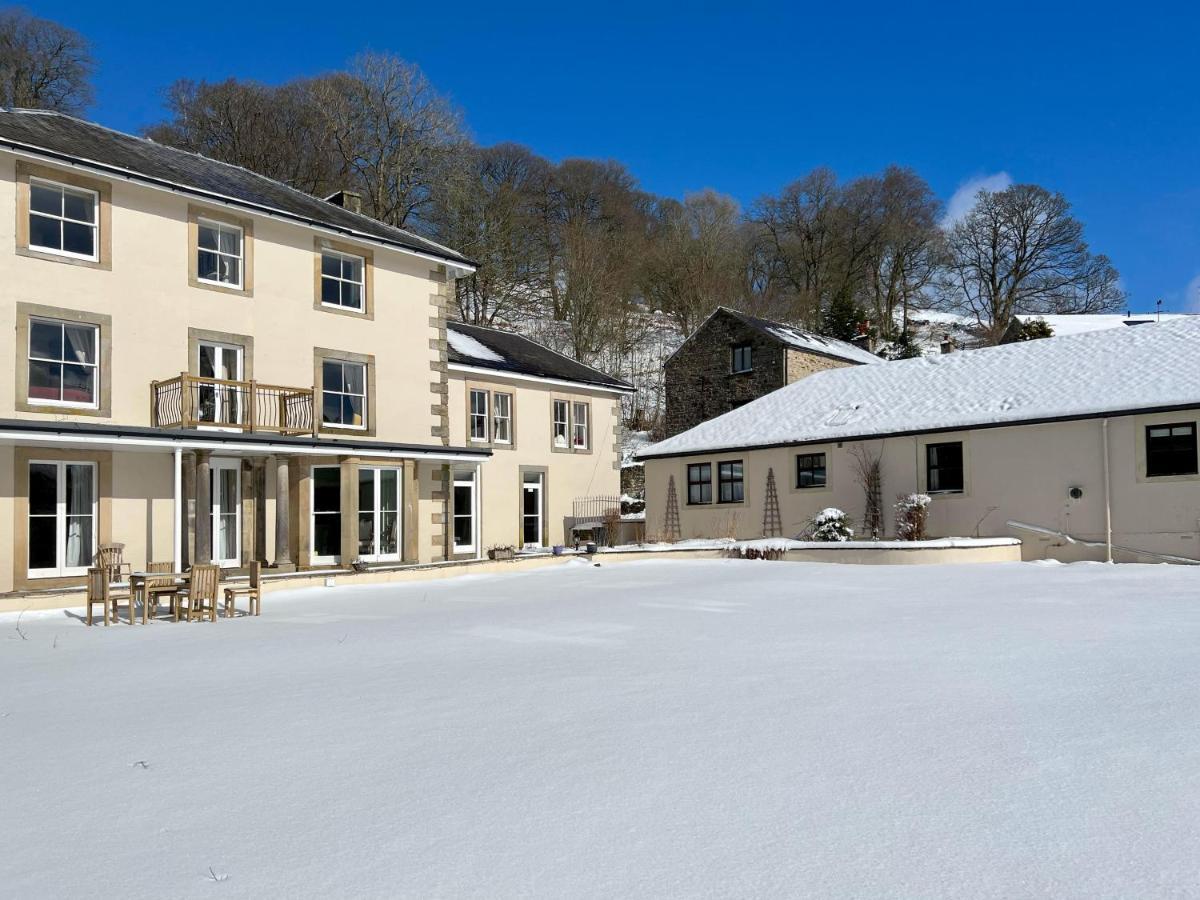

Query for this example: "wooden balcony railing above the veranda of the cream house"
[150,372,317,434]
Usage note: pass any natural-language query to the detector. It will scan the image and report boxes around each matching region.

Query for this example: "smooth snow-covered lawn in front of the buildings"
[0,560,1200,899]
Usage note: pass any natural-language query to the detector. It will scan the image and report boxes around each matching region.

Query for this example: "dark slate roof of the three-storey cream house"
[0,107,474,265]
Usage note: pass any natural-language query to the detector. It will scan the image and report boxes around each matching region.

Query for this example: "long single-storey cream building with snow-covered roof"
[638,317,1200,560]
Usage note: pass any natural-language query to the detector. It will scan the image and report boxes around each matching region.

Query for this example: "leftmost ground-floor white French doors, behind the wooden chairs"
[29,462,96,577]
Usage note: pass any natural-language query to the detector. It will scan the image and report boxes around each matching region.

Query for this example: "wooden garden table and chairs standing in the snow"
[88,544,263,625]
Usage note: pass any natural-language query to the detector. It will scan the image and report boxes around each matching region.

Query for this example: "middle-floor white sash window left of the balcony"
[29,318,100,408]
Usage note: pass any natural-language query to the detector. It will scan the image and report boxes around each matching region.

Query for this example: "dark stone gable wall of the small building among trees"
[665,313,787,437]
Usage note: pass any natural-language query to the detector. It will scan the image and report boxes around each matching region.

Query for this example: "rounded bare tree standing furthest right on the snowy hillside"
[944,185,1124,343]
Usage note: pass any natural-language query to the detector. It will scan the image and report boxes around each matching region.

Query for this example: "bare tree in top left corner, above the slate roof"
[0,7,96,113]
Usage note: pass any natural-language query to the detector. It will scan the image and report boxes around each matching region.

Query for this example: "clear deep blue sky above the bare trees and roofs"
[26,0,1200,310]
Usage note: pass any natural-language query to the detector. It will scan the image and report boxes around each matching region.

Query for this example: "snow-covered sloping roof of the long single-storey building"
[638,316,1200,458]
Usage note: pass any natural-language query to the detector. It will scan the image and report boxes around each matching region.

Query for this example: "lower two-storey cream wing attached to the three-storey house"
[448,323,634,556]
